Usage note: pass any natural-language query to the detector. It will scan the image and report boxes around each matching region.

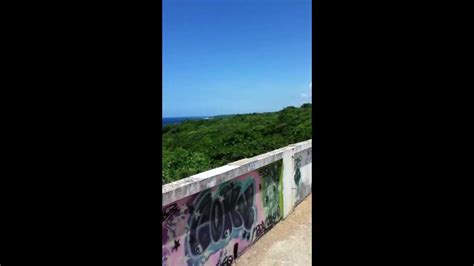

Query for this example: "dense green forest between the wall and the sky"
[162,104,312,183]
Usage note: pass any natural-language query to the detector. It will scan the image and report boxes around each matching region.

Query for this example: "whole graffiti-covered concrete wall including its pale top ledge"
[162,140,311,266]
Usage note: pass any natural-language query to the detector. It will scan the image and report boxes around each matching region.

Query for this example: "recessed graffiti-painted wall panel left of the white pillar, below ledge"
[162,160,283,266]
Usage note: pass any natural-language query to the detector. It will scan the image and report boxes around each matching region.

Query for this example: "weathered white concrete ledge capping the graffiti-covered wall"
[162,139,312,206]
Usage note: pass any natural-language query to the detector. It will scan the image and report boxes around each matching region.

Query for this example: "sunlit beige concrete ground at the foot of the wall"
[235,194,312,266]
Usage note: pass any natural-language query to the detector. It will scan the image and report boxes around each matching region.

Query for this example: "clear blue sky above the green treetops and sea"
[163,0,312,117]
